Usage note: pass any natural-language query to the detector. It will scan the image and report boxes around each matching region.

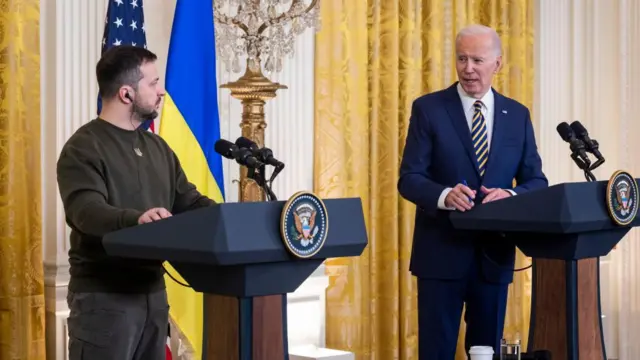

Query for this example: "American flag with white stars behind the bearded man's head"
[98,0,154,132]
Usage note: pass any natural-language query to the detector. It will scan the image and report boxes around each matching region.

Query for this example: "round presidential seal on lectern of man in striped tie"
[607,171,638,225]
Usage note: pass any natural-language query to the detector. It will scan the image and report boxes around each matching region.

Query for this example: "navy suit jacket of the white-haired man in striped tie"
[398,83,548,283]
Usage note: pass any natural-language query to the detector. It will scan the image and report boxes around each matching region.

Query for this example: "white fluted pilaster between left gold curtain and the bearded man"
[40,0,106,360]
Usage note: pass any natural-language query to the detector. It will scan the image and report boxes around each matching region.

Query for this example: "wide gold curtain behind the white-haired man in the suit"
[314,0,534,360]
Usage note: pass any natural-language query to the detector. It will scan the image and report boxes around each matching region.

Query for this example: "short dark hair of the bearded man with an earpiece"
[96,45,158,99]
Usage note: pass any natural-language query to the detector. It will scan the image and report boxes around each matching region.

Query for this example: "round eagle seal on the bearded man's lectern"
[280,191,329,258]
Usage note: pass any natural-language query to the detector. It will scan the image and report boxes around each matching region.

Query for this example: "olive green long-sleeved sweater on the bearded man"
[57,119,215,293]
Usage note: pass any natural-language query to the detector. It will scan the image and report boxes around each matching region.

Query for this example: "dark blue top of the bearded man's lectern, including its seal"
[103,195,368,266]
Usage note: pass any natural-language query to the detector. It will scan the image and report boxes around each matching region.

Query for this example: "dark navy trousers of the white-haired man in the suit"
[418,261,508,360]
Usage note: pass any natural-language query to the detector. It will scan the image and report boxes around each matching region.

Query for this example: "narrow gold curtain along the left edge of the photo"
[0,0,45,360]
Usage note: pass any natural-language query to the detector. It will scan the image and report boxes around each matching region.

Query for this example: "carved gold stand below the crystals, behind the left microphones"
[221,64,287,202]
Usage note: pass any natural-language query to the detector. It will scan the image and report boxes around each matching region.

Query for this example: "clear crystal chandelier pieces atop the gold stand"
[214,0,320,73]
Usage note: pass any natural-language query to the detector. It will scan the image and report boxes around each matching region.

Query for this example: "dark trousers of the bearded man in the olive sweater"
[67,290,169,360]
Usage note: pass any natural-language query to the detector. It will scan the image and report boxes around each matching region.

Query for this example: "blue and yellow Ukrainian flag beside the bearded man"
[160,0,224,359]
